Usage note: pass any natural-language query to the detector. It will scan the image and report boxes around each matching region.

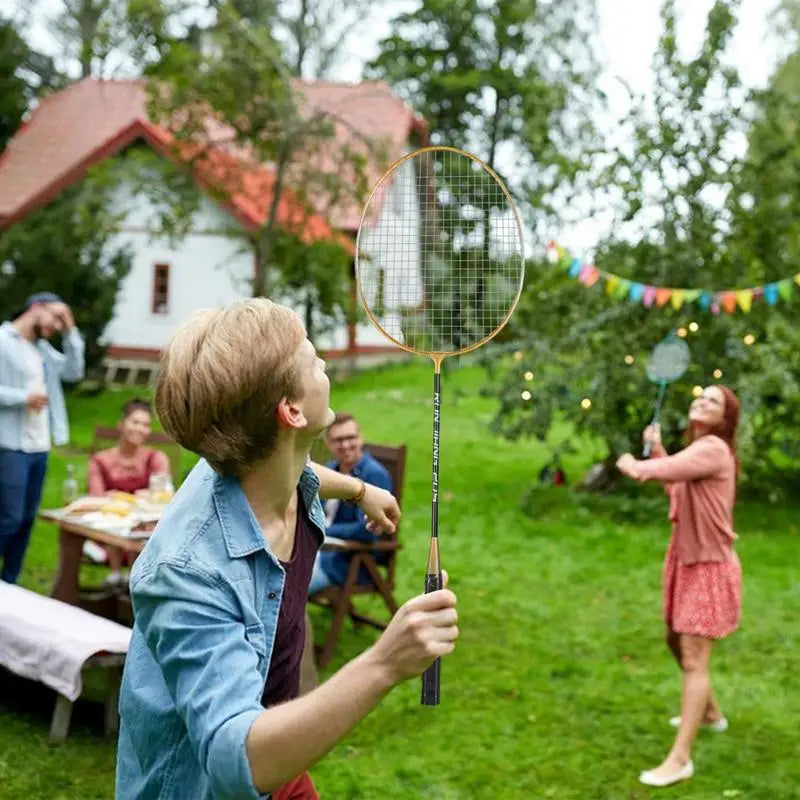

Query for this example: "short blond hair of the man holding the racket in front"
[156,297,306,475]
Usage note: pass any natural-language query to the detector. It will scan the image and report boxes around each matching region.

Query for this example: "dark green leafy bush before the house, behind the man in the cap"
[0,168,131,366]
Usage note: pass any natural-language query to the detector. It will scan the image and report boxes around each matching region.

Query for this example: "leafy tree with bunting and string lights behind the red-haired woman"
[488,0,799,500]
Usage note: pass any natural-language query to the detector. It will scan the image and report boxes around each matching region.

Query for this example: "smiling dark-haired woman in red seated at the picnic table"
[88,397,170,585]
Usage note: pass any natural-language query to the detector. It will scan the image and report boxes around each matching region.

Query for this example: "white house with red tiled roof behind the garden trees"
[0,78,427,368]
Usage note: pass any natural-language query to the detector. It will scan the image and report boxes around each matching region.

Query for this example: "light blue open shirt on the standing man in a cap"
[0,322,84,450]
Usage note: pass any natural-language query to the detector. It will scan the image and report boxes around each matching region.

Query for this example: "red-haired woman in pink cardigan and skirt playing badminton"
[617,386,742,786]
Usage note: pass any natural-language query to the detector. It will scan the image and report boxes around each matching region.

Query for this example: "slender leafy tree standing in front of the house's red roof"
[128,2,373,340]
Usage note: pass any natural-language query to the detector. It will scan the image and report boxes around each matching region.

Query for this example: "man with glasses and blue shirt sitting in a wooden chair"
[308,413,392,595]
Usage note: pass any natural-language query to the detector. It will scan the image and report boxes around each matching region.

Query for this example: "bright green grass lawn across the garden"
[0,361,800,800]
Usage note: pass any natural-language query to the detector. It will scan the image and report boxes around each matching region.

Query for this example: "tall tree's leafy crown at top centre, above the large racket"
[365,0,595,198]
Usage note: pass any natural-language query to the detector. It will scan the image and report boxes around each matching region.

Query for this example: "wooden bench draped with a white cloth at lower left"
[0,581,131,741]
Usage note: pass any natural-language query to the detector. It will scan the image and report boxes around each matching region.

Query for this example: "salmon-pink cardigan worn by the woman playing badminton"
[632,436,737,564]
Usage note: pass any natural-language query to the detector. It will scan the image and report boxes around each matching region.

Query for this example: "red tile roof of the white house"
[0,78,426,240]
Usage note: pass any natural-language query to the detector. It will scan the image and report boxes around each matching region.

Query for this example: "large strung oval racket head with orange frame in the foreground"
[355,146,525,359]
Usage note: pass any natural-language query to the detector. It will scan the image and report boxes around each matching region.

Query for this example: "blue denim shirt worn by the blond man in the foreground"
[115,461,325,800]
